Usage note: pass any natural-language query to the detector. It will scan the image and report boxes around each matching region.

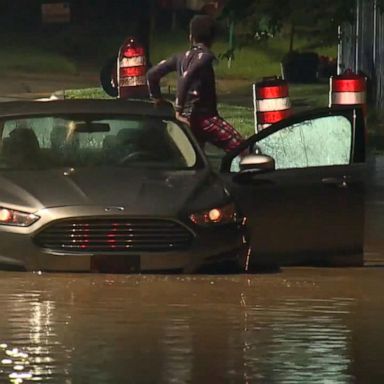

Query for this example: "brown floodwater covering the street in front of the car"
[0,267,384,384]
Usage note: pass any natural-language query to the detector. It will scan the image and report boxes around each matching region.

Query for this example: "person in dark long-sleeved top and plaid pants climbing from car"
[147,15,244,152]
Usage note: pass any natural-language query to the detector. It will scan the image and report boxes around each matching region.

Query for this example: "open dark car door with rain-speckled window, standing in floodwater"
[221,108,365,266]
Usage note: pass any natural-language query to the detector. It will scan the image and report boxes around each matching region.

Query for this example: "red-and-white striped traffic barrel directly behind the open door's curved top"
[253,76,292,132]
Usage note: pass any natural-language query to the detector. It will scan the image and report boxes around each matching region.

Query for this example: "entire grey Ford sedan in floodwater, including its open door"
[0,100,367,272]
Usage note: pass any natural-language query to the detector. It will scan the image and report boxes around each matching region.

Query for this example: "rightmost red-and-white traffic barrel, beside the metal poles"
[329,70,367,111]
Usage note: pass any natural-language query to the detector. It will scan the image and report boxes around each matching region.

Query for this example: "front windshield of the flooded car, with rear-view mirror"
[0,116,198,170]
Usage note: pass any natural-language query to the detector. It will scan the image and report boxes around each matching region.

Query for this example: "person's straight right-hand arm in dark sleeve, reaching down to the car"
[175,52,215,114]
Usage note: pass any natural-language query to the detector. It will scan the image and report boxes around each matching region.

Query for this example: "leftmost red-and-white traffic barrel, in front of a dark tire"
[117,37,148,99]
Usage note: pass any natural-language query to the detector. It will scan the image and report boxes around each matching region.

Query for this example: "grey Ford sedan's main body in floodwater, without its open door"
[0,100,248,273]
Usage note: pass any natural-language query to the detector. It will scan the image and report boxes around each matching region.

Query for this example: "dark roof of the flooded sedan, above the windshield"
[0,99,174,119]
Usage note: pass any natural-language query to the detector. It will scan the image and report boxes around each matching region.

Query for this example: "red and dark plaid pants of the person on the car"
[190,115,244,152]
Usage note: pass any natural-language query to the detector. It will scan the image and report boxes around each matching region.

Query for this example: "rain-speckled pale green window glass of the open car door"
[256,116,353,169]
